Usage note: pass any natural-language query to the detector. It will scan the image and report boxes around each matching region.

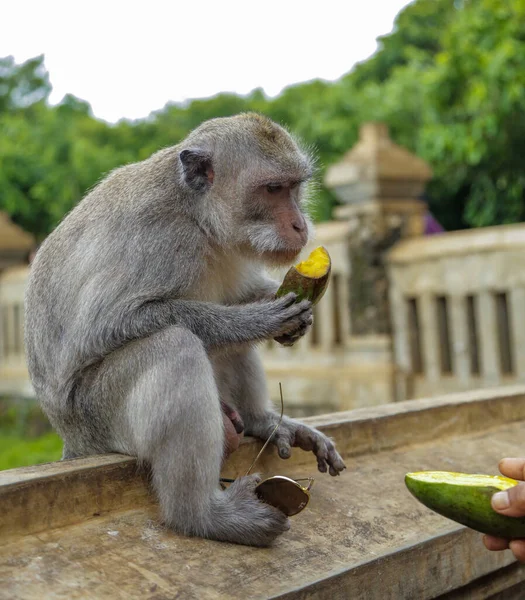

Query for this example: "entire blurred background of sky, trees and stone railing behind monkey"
[0,0,525,469]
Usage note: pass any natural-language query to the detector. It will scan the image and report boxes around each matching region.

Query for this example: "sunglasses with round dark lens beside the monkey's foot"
[220,383,314,517]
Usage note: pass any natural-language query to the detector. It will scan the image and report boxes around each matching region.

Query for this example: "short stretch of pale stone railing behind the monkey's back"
[0,266,32,396]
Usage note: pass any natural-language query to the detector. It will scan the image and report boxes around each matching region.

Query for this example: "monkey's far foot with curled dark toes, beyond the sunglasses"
[246,412,346,477]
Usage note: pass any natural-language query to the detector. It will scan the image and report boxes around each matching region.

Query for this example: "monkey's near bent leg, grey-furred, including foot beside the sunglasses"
[87,327,289,546]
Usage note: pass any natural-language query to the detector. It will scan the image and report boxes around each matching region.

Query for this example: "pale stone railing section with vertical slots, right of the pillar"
[388,224,525,400]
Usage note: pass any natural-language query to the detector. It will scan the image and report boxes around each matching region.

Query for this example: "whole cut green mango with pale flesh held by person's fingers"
[405,471,525,540]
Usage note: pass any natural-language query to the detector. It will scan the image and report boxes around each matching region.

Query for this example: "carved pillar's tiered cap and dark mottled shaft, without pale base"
[325,123,432,336]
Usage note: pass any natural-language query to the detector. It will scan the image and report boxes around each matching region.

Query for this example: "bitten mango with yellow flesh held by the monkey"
[276,246,332,304]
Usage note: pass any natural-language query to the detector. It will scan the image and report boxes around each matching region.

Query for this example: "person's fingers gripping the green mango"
[483,458,525,562]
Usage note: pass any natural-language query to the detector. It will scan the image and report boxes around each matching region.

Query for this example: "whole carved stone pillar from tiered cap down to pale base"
[325,123,432,408]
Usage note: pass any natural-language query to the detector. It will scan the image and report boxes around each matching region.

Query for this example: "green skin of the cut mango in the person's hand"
[405,473,525,540]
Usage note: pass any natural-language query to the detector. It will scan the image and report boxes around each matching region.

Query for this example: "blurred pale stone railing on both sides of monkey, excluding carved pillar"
[0,221,525,416]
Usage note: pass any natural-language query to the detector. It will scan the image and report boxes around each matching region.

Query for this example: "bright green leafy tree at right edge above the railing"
[422,0,525,227]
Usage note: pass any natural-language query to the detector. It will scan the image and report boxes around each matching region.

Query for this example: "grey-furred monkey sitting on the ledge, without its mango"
[26,114,344,546]
